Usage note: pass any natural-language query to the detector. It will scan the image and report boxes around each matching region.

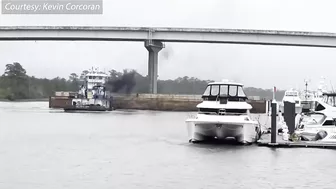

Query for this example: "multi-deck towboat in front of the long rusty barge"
[64,68,113,112]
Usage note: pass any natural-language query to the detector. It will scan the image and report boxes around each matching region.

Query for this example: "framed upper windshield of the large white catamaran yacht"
[203,84,246,97]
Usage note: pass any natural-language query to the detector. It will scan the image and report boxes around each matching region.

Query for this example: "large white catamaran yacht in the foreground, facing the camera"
[186,81,260,143]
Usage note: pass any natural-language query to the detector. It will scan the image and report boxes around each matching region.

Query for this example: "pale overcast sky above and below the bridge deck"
[0,0,336,88]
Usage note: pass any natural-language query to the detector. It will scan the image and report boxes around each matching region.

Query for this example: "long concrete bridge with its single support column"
[0,26,336,93]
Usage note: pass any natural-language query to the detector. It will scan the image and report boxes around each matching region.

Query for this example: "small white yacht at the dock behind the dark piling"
[279,89,302,114]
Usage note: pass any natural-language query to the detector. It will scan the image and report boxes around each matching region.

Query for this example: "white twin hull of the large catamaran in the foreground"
[186,119,259,144]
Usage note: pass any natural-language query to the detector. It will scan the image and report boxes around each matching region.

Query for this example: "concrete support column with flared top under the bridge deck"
[145,40,164,94]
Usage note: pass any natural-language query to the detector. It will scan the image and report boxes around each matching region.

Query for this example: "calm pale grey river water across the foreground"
[0,102,336,189]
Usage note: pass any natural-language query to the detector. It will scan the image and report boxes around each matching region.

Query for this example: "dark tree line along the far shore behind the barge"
[0,62,284,100]
